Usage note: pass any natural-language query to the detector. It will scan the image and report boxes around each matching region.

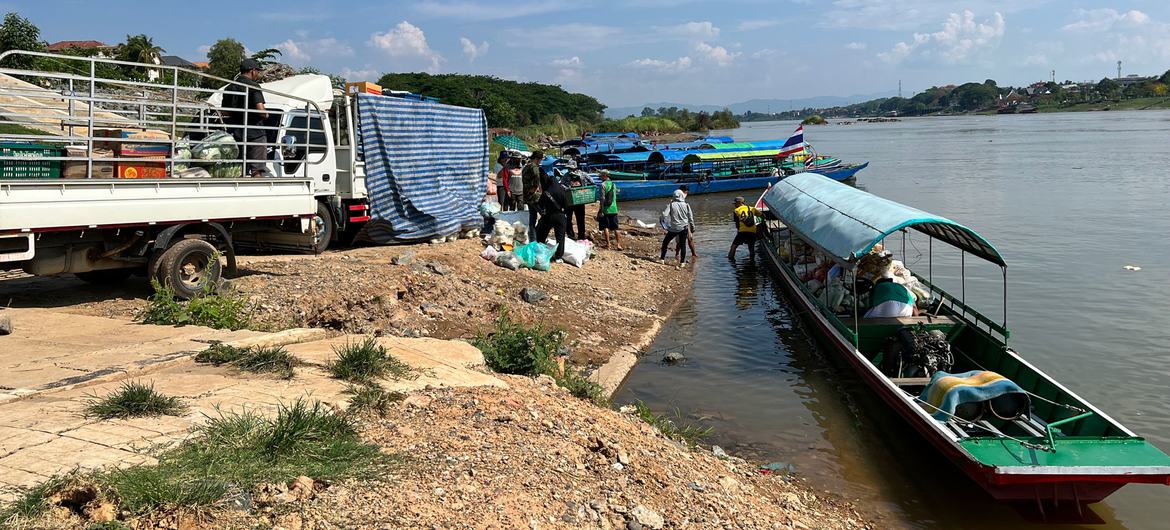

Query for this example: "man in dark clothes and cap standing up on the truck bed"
[220,58,268,177]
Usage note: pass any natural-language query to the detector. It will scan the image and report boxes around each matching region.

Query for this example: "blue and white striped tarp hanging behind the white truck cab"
[358,94,489,245]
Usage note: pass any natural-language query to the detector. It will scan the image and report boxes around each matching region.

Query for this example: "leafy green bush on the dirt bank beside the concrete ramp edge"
[472,310,565,376]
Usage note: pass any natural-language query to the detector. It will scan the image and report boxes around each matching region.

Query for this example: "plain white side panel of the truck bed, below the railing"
[0,178,317,234]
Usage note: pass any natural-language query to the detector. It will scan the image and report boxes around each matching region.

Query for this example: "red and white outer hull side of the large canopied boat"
[757,238,1170,504]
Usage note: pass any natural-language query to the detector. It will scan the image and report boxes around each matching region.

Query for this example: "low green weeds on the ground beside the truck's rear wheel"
[142,280,250,330]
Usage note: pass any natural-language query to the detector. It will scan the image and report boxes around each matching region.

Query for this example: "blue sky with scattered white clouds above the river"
[9,0,1170,106]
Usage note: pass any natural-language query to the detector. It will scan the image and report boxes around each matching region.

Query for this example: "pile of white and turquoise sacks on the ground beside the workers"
[480,220,593,270]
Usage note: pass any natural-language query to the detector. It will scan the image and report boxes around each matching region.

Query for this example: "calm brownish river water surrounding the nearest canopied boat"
[615,111,1170,529]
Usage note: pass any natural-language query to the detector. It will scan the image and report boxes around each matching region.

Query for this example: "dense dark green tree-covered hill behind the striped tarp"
[379,73,605,129]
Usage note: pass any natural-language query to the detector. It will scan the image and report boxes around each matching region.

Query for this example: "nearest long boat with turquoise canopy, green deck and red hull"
[758,173,1170,514]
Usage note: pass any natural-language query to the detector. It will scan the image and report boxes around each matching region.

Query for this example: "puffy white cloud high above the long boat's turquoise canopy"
[878,11,1005,63]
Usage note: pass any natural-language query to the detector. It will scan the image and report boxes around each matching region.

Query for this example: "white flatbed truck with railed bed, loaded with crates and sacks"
[0,51,369,297]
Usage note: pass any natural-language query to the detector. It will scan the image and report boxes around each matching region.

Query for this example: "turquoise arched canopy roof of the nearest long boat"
[764,173,1007,267]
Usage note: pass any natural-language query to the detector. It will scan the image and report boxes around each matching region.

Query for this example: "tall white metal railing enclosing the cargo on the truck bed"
[0,50,330,183]
